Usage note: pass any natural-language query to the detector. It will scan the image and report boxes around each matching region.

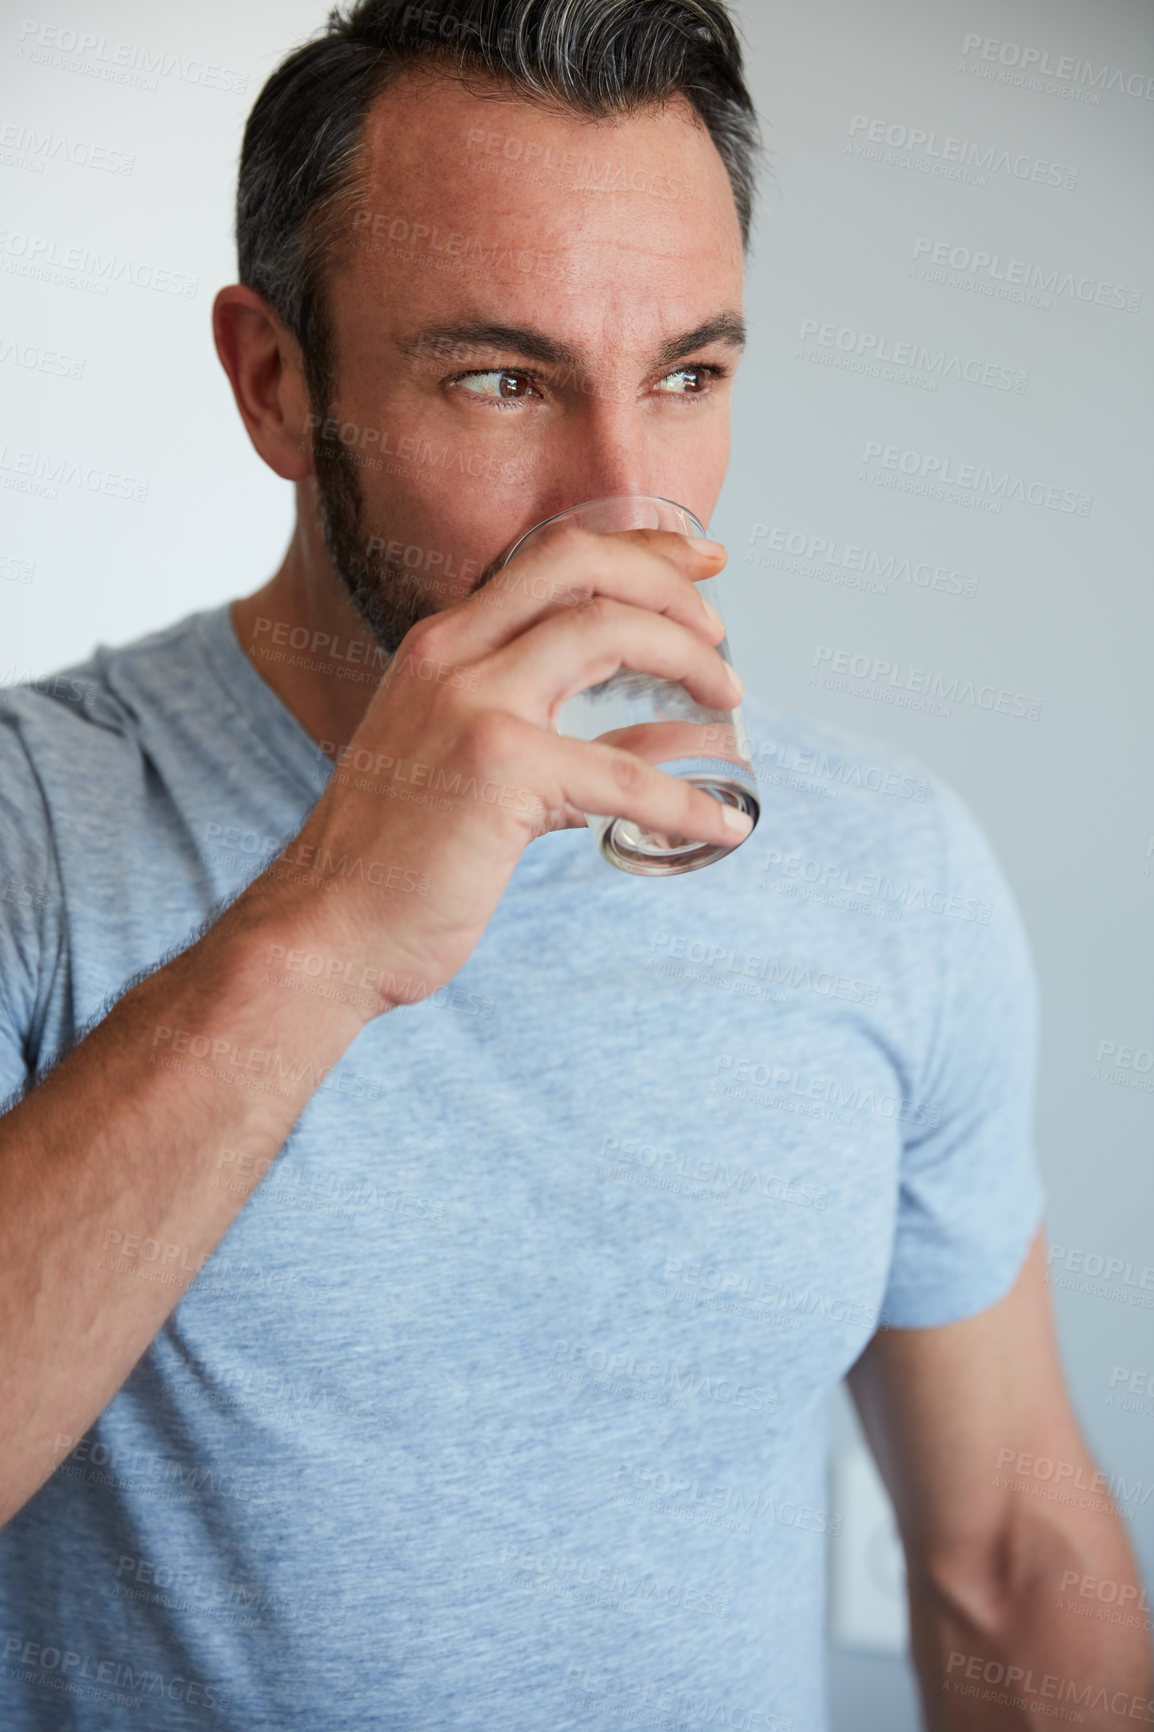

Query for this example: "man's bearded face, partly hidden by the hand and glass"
[305,71,742,653]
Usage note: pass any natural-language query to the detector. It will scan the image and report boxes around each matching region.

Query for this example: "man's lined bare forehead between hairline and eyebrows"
[348,73,742,357]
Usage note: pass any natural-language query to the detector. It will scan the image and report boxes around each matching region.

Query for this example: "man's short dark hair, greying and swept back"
[236,0,761,402]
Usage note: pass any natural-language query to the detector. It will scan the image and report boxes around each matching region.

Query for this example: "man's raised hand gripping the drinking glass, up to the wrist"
[256,525,749,1010]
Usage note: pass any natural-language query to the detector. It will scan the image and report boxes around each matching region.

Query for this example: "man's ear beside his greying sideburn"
[213,282,315,481]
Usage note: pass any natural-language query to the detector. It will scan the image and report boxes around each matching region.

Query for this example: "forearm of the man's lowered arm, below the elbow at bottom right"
[910,1514,1154,1732]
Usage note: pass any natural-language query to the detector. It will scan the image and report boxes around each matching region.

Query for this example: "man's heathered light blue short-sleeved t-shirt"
[0,608,1041,1732]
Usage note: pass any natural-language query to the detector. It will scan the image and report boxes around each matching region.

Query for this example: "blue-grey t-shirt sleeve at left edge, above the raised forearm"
[0,703,62,1112]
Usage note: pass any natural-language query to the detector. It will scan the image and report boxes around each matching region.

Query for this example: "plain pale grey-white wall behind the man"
[0,0,1154,1732]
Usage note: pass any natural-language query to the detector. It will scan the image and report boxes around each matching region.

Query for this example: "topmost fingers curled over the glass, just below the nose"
[426,523,726,662]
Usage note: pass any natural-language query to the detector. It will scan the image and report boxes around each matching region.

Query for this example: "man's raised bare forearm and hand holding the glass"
[0,530,740,1521]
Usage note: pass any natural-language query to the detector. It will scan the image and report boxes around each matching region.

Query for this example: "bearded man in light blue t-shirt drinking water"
[0,0,1151,1732]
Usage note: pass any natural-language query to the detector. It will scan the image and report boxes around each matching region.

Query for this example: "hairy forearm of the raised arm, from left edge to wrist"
[0,889,386,1521]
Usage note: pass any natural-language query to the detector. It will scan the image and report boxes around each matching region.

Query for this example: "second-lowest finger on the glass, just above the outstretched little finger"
[475,596,743,727]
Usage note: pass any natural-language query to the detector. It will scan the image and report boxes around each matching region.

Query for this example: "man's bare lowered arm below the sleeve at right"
[849,1237,1154,1732]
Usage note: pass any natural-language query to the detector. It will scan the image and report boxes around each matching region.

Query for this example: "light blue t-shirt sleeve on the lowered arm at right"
[880,783,1045,1328]
